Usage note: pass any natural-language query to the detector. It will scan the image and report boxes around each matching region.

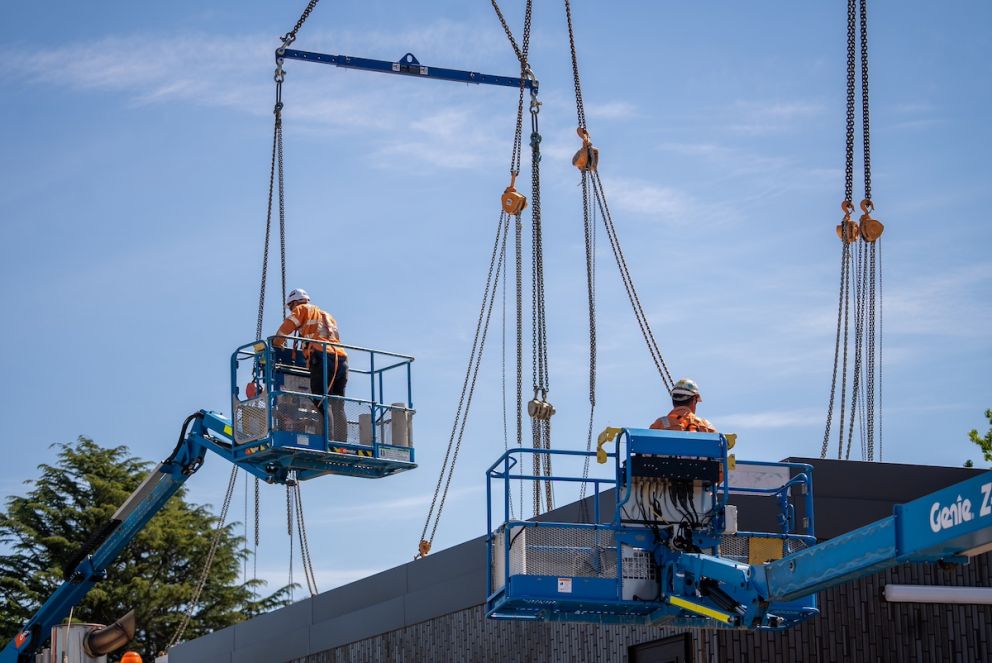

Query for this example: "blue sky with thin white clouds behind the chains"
[0,1,992,596]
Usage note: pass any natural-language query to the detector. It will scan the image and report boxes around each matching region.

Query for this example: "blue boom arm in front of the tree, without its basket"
[0,410,246,663]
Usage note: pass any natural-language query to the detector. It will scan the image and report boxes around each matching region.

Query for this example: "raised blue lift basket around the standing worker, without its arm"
[231,336,417,480]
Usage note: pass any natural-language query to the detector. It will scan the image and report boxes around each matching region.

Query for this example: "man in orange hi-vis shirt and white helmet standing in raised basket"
[272,289,348,442]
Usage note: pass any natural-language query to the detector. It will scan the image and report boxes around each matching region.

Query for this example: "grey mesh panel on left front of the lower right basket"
[509,526,617,578]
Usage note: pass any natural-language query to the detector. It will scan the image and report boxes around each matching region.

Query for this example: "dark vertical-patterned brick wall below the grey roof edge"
[293,554,992,663]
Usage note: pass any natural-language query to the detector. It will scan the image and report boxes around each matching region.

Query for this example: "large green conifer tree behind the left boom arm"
[0,437,290,660]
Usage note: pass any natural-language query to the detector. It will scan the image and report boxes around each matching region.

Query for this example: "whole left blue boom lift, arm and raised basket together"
[0,337,416,663]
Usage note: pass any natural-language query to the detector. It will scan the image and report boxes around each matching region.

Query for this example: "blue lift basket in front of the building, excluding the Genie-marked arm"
[486,429,817,629]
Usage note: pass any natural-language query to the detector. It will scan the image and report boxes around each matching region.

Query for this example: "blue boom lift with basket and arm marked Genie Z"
[486,428,992,630]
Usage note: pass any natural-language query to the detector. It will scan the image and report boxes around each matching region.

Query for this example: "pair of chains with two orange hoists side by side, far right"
[820,0,885,461]
